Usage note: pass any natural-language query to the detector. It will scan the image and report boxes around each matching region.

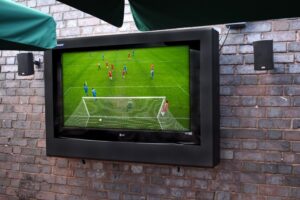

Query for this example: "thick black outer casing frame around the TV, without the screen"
[44,28,220,167]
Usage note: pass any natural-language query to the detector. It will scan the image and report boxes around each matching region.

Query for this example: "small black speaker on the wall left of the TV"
[17,53,34,76]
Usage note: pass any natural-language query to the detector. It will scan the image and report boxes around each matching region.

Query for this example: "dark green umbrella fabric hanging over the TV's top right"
[129,0,300,31]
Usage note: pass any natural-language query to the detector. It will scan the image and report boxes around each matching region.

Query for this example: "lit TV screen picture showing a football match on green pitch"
[62,46,190,131]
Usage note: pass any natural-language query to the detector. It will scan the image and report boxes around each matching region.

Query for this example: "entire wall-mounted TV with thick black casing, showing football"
[45,29,219,167]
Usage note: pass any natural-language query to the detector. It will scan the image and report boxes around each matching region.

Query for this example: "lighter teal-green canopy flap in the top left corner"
[0,0,56,50]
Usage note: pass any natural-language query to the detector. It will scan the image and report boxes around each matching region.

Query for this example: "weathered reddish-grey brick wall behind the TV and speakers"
[0,0,300,200]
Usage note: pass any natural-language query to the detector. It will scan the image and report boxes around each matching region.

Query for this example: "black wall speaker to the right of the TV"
[253,40,274,70]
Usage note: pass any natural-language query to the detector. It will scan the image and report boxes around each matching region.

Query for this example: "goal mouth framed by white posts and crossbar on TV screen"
[82,96,166,129]
